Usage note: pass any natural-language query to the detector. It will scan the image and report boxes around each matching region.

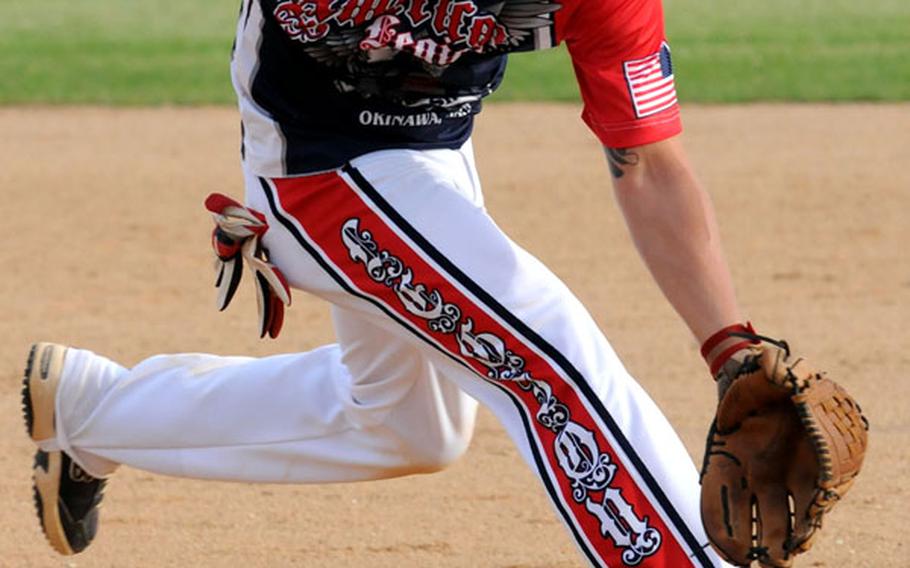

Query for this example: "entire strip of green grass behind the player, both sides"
[0,0,910,105]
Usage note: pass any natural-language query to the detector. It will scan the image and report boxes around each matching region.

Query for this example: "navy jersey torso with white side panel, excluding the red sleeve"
[233,0,558,175]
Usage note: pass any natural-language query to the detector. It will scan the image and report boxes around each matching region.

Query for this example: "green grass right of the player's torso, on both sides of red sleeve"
[495,0,910,102]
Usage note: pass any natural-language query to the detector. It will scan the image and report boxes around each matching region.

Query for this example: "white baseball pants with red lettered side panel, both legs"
[56,143,721,567]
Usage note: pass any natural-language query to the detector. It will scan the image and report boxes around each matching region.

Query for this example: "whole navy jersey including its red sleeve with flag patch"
[231,0,678,177]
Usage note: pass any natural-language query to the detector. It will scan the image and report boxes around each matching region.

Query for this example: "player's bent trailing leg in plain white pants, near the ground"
[45,308,476,483]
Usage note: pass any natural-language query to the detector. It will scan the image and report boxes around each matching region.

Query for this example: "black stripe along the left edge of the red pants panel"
[259,177,600,566]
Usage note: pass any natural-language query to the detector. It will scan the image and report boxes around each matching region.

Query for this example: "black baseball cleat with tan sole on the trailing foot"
[22,343,106,555]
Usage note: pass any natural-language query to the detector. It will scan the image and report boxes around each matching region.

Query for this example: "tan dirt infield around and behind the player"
[0,105,910,567]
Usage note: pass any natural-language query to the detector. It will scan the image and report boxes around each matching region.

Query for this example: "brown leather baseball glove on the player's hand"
[701,334,868,567]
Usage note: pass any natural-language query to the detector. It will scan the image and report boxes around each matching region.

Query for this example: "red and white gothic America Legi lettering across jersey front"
[273,0,558,66]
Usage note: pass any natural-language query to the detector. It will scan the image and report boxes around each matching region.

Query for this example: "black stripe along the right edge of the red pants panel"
[343,164,714,567]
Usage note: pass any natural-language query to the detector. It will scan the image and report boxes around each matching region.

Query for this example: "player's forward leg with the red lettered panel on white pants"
[254,143,719,566]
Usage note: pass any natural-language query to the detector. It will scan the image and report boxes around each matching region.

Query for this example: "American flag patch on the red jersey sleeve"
[622,42,676,118]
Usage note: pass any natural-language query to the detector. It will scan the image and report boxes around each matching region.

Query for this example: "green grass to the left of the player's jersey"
[0,0,238,105]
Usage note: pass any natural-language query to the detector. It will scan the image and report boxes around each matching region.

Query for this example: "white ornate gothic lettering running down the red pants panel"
[341,218,661,566]
